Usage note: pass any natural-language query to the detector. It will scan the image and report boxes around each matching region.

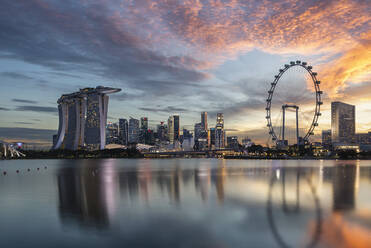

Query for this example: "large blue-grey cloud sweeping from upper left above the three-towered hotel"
[0,0,207,99]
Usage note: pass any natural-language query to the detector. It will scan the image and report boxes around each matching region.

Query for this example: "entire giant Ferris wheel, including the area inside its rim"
[265,60,323,146]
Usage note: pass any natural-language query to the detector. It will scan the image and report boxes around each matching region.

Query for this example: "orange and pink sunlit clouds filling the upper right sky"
[144,0,371,95]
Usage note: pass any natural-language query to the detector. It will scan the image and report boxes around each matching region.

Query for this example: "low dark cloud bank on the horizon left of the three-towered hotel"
[0,127,57,142]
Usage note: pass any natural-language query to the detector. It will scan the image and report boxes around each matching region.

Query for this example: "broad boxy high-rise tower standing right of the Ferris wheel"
[331,102,356,143]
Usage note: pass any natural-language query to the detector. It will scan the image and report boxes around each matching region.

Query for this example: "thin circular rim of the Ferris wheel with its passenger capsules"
[265,60,323,141]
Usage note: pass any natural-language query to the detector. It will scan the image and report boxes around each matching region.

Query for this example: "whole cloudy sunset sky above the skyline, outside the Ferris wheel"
[0,0,371,143]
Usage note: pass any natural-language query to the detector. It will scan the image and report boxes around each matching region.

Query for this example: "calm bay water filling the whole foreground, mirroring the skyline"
[0,159,371,248]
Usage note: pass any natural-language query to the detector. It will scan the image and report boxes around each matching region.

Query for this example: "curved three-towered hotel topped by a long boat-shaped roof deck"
[53,86,121,150]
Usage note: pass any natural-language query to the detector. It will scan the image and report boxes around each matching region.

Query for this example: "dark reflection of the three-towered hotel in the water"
[57,160,117,228]
